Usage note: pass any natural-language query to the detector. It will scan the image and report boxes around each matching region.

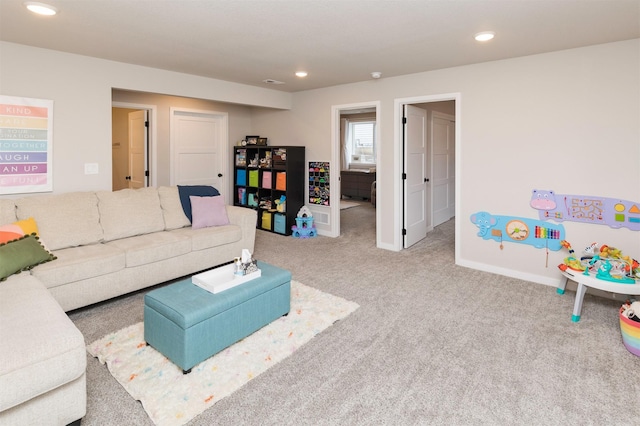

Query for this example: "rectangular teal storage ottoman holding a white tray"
[144,261,291,374]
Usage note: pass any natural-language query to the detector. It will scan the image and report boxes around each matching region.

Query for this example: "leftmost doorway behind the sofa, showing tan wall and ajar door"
[111,102,157,191]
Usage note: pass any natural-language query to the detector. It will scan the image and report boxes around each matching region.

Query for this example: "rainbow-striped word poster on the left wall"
[0,95,53,194]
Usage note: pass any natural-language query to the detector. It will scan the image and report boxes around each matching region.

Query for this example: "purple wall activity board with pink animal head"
[531,189,640,231]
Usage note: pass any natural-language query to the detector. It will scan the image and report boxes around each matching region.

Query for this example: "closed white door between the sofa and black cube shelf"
[171,108,228,200]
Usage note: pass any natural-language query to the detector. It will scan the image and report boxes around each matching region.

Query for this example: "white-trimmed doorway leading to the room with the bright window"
[328,101,381,247]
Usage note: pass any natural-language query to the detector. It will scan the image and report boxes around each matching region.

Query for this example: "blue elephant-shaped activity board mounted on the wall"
[471,212,565,251]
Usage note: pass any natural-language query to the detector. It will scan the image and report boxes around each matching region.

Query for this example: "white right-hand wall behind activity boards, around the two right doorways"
[253,39,640,285]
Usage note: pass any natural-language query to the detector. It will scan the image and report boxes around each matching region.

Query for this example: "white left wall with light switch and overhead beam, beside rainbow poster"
[0,42,291,193]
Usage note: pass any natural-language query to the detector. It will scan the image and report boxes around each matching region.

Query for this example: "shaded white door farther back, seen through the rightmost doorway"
[431,113,456,226]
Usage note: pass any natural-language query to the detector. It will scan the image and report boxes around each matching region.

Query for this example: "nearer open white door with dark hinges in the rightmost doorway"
[404,105,429,248]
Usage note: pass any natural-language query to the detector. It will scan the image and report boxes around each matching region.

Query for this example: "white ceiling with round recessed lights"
[0,0,640,92]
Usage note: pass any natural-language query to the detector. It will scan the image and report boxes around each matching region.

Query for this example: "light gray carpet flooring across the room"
[70,203,640,426]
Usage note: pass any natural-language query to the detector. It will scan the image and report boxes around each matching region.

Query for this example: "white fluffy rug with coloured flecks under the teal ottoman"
[87,281,358,425]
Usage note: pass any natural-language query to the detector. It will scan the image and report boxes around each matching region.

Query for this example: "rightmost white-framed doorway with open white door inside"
[395,94,460,250]
